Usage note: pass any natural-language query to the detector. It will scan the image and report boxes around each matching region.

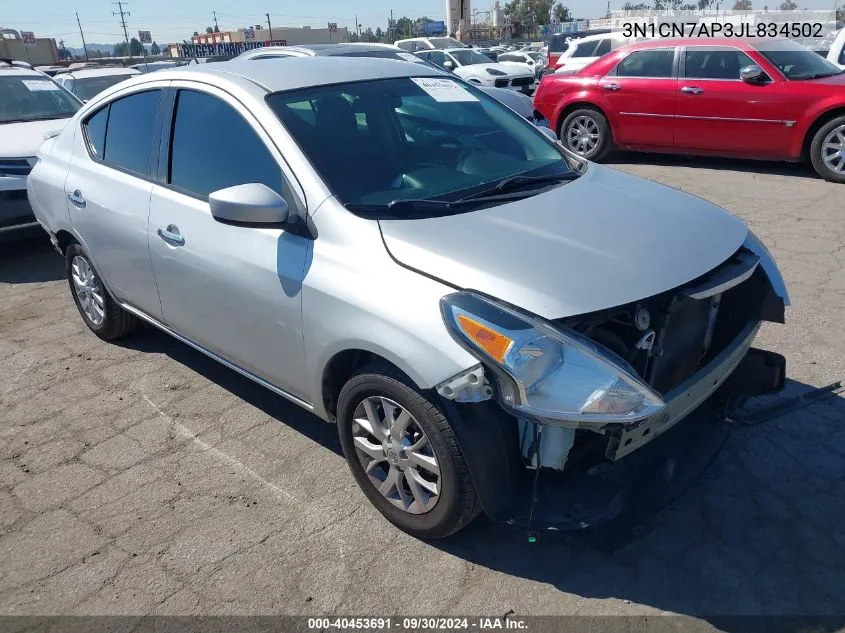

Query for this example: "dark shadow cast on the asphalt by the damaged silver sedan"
[115,320,845,633]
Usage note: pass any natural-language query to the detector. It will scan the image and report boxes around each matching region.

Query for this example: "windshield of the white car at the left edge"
[0,75,80,123]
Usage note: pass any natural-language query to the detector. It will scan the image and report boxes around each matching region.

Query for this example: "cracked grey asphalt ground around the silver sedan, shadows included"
[0,155,845,622]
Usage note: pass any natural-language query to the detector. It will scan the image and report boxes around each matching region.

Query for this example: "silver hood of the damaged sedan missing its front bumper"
[379,165,748,319]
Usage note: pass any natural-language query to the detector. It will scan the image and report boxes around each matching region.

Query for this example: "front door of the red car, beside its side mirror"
[675,46,787,158]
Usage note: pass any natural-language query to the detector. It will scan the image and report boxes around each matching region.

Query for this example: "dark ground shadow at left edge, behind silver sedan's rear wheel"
[0,233,65,284]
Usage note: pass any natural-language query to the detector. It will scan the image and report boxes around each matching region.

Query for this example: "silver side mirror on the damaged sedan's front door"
[208,182,290,224]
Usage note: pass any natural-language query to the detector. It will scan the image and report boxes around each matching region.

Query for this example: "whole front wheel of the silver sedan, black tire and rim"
[337,364,479,539]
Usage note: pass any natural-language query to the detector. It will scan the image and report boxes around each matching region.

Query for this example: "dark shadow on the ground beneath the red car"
[603,151,820,180]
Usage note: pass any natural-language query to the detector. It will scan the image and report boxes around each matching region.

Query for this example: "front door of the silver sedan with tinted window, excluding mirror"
[148,87,312,396]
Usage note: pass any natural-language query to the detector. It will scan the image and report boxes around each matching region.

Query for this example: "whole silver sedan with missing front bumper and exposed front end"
[28,57,788,537]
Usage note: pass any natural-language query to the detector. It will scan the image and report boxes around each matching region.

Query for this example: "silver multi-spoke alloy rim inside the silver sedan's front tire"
[352,396,441,514]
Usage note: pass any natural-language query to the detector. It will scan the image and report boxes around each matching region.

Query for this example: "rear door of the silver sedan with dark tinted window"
[65,83,166,316]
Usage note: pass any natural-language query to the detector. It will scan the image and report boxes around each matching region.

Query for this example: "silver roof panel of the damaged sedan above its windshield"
[156,56,446,92]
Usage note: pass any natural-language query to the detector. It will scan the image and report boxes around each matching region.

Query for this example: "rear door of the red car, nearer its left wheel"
[597,47,678,149]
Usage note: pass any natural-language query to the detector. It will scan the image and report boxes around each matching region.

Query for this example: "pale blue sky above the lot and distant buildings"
[0,0,834,47]
